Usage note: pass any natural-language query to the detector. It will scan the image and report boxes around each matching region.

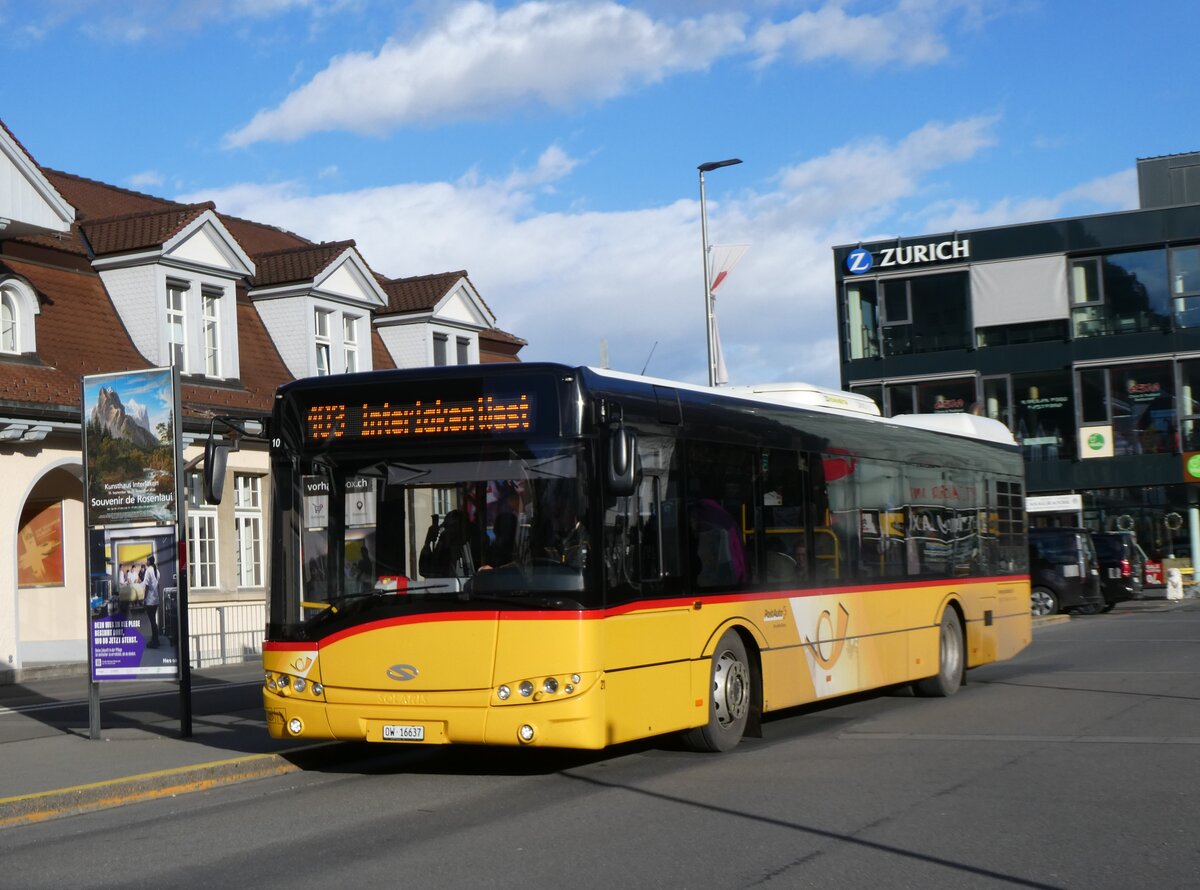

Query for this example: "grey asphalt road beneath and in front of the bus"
[0,601,1200,890]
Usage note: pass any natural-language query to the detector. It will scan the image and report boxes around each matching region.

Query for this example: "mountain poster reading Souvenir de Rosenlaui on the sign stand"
[83,368,175,528]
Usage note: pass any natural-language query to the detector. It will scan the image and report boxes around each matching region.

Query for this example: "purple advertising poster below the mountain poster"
[88,525,179,681]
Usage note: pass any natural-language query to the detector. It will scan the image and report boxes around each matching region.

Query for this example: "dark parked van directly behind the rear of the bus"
[1030,528,1104,615]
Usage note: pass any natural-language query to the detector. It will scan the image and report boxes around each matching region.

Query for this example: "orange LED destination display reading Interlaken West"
[305,393,534,441]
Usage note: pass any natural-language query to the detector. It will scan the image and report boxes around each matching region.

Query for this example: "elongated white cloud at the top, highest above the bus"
[226,1,743,148]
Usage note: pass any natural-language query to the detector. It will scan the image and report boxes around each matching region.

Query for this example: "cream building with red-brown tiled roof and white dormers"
[0,115,526,682]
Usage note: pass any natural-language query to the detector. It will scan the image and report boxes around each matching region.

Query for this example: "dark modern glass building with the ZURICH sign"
[834,152,1200,570]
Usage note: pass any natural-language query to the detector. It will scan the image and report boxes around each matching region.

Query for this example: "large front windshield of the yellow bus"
[286,443,588,623]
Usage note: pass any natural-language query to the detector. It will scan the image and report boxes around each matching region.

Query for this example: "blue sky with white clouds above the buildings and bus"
[0,0,1200,386]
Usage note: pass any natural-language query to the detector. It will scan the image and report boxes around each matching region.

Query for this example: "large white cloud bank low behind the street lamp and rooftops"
[184,116,1128,386]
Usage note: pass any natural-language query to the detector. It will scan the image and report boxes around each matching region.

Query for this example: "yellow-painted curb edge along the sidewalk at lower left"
[0,754,302,829]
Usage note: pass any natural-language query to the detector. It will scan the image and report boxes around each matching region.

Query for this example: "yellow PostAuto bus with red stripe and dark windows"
[205,363,1031,751]
